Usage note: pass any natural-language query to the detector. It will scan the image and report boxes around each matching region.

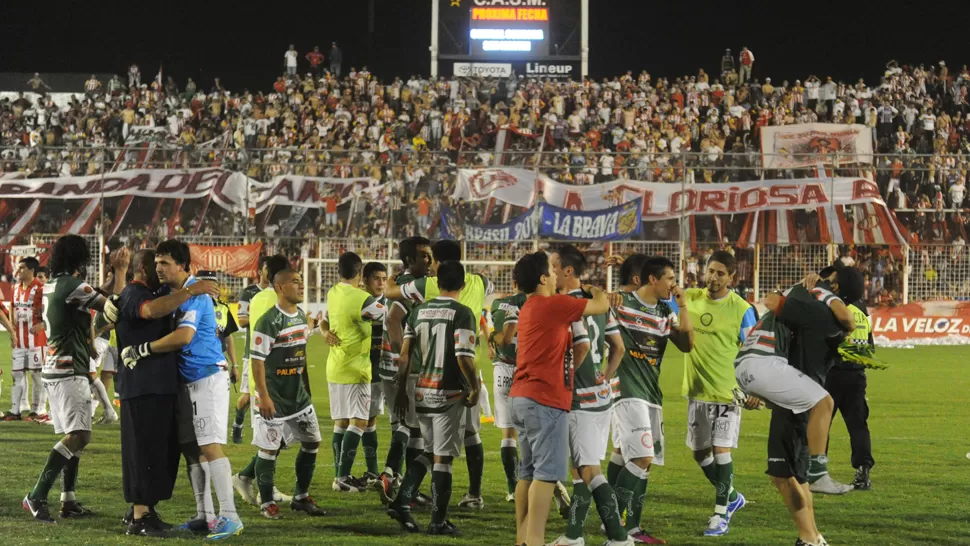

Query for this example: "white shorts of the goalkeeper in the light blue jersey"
[178,370,229,446]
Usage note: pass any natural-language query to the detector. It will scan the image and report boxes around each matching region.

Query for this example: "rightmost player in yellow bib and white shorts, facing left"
[683,250,758,536]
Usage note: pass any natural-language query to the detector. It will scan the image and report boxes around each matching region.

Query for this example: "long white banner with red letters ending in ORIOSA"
[455,168,885,217]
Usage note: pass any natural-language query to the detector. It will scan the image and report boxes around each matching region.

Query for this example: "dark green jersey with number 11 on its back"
[404,296,476,413]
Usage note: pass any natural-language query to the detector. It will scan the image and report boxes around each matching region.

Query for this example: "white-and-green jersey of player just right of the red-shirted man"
[569,289,620,411]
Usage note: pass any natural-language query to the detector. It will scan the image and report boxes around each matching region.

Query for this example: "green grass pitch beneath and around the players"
[0,334,970,546]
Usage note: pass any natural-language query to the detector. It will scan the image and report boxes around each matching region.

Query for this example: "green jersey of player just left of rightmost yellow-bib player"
[612,292,678,407]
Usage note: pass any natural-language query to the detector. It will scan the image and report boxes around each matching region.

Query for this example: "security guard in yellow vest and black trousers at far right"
[825,300,876,491]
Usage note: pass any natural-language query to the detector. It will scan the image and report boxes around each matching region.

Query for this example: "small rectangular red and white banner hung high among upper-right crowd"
[760,123,872,169]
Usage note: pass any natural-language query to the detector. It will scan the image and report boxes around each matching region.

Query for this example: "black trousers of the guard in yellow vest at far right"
[825,366,876,468]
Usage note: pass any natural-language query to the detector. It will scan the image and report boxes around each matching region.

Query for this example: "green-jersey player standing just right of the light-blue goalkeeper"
[251,269,326,519]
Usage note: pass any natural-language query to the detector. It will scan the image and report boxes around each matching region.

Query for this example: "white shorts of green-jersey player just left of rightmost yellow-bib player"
[613,398,664,466]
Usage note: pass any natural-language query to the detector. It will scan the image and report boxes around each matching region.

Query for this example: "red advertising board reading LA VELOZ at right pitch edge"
[869,301,970,346]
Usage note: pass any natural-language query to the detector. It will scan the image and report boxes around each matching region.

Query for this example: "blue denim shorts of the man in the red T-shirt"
[509,396,569,482]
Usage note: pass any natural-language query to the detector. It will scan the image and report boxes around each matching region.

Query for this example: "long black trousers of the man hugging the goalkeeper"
[121,394,180,506]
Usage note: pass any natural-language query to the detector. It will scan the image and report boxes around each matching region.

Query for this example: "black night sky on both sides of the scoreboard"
[0,0,970,91]
